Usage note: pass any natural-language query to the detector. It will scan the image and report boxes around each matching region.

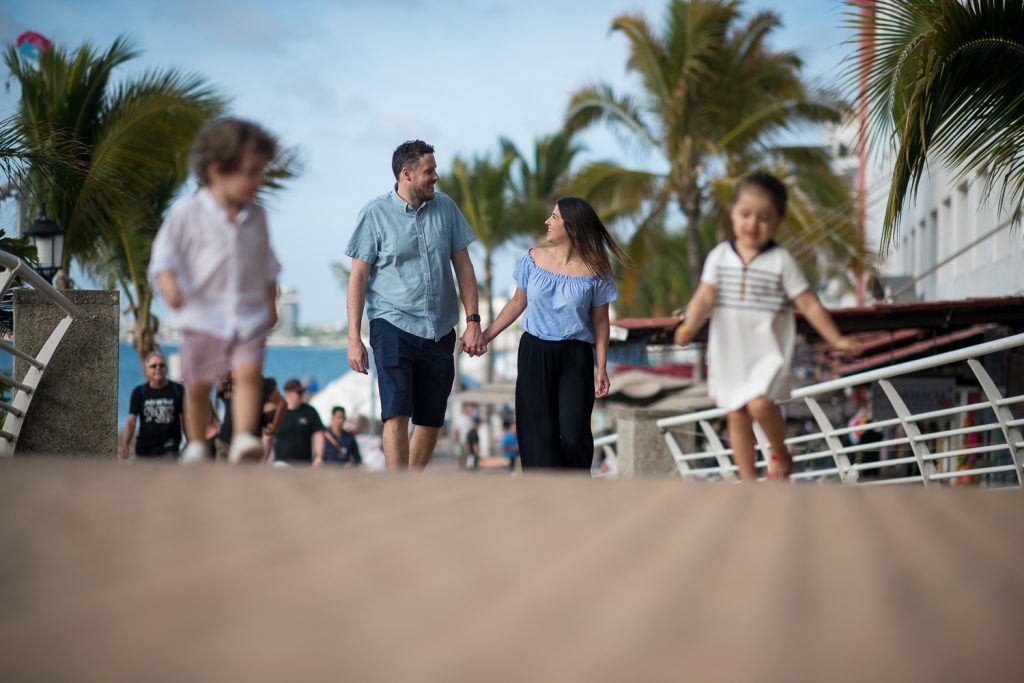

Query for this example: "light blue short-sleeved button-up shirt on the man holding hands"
[345,189,476,341]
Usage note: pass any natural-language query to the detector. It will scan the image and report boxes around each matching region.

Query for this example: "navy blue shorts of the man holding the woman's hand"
[370,318,455,427]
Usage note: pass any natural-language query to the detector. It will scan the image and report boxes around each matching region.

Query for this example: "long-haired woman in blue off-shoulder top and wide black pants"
[483,197,627,470]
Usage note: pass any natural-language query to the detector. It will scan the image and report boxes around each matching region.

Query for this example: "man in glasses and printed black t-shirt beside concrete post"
[118,352,185,458]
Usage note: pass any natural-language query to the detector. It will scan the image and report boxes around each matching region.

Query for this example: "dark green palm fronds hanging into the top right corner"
[848,0,1024,248]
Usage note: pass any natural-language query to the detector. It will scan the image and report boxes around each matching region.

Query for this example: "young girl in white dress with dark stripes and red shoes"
[675,173,861,479]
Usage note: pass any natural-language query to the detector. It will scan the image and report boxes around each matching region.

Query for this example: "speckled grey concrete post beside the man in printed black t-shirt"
[14,289,121,458]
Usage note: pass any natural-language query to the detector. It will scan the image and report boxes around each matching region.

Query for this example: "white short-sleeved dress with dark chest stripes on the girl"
[700,242,809,411]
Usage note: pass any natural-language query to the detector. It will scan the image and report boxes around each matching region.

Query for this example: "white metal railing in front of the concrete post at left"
[0,251,81,458]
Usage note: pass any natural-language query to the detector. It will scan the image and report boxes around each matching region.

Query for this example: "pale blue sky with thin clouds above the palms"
[0,0,848,324]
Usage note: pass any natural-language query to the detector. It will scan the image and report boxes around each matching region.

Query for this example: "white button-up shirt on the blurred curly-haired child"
[148,187,281,339]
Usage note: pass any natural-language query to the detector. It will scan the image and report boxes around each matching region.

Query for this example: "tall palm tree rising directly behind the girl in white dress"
[565,0,864,312]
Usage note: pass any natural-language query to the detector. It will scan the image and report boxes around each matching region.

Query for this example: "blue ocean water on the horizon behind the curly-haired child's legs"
[118,342,348,428]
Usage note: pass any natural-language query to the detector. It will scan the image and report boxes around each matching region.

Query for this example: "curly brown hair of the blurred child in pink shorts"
[191,118,278,185]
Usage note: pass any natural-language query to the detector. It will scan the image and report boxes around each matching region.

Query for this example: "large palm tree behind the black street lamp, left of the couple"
[4,37,224,357]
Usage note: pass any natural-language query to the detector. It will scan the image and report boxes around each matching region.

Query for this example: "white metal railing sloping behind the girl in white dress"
[651,334,1024,486]
